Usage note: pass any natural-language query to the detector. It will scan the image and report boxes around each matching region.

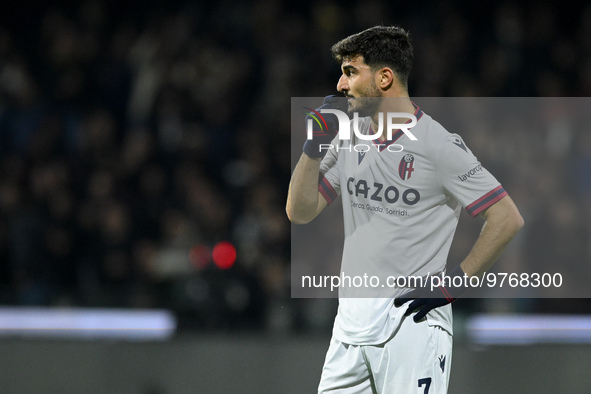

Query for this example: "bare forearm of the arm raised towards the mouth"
[285,153,328,224]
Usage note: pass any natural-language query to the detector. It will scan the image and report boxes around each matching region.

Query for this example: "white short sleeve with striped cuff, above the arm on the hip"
[437,134,507,217]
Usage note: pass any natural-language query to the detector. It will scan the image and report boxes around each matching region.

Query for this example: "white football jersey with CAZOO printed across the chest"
[319,106,507,344]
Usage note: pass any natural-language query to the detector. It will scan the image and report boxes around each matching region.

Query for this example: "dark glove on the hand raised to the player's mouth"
[303,95,348,158]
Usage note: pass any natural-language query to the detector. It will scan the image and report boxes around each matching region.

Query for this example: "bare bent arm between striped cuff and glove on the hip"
[461,196,524,276]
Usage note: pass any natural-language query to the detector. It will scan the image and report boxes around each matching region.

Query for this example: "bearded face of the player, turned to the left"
[337,56,382,116]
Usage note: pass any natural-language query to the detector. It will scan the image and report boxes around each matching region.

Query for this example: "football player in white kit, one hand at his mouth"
[286,26,523,394]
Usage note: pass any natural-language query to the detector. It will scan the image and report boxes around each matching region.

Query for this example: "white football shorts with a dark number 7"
[318,316,452,394]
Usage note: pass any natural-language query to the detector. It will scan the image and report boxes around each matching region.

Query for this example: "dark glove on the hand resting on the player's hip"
[394,265,469,323]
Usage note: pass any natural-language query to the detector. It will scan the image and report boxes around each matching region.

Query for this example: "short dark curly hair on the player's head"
[332,26,413,88]
